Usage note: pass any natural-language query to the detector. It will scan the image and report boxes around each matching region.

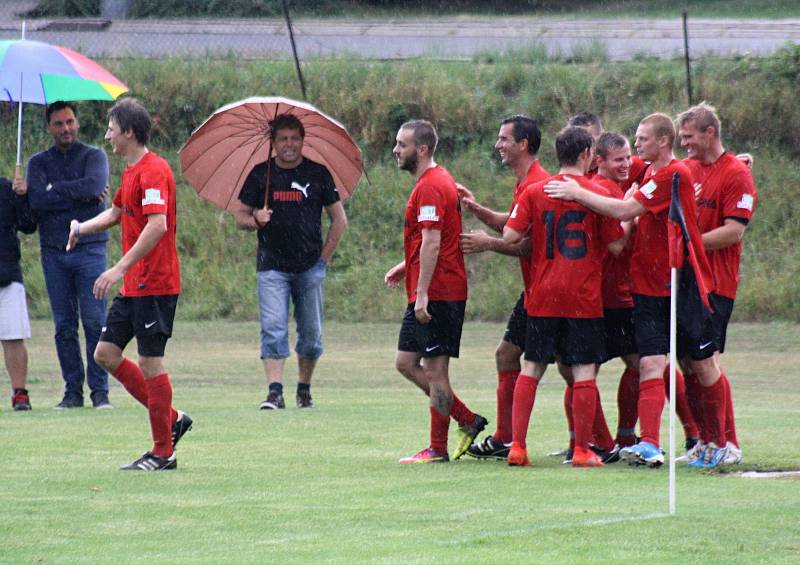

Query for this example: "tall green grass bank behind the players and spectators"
[6,46,800,320]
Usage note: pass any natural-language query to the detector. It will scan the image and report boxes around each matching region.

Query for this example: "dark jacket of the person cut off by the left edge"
[0,177,36,286]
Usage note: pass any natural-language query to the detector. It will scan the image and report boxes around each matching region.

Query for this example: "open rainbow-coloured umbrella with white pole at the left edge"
[0,32,128,167]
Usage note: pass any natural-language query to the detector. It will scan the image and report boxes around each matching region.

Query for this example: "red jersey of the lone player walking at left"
[114,151,181,296]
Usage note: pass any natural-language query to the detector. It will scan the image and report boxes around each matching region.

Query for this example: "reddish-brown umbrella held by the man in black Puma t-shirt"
[180,96,364,211]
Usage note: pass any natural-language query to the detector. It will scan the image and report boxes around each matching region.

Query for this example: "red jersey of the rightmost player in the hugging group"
[684,152,758,300]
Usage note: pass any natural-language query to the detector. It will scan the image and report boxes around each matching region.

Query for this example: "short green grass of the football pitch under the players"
[0,321,800,564]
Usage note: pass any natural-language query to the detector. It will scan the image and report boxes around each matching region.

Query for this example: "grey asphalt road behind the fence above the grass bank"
[0,0,800,61]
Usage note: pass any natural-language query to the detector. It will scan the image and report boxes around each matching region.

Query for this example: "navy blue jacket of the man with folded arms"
[27,141,108,251]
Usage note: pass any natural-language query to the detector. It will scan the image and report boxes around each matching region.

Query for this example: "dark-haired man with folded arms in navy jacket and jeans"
[14,102,112,409]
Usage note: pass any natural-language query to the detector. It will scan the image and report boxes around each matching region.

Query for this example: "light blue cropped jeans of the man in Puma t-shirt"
[258,259,328,359]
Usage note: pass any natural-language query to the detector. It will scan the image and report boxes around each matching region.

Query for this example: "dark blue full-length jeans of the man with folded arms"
[42,242,108,398]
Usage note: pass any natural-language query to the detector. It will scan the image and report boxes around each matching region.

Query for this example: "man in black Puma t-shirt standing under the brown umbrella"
[231,114,347,410]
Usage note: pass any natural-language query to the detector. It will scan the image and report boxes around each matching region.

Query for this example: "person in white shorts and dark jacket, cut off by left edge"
[0,178,36,410]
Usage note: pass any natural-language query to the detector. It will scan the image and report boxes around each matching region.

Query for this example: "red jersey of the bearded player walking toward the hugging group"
[403,165,467,303]
